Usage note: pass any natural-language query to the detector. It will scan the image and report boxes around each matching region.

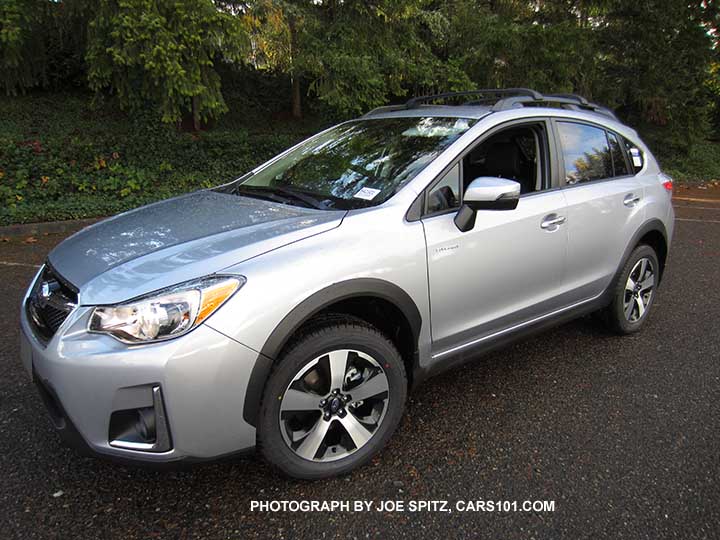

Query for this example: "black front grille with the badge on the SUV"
[26,264,78,340]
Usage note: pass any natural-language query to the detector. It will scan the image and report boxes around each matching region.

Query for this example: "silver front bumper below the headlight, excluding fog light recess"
[21,296,258,463]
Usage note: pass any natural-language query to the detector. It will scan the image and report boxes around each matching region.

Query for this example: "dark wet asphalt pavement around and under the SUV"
[0,202,720,540]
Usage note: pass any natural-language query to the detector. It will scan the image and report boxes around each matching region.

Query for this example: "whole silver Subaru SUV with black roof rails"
[21,89,673,478]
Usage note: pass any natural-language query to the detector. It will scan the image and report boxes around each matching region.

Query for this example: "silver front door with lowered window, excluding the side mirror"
[422,122,568,357]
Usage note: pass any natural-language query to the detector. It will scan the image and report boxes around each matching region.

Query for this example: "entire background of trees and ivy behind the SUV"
[0,0,720,223]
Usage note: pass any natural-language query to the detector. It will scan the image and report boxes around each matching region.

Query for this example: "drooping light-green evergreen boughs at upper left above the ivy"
[86,0,248,130]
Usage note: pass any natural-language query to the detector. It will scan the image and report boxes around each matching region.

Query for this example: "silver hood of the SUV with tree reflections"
[48,191,346,305]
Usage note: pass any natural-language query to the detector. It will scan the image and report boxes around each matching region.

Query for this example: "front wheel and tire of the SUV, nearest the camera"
[257,316,407,480]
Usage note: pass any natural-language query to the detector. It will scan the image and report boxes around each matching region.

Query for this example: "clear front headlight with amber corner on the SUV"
[88,276,245,343]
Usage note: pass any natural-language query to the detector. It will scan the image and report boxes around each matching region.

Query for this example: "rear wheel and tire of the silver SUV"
[602,244,660,335]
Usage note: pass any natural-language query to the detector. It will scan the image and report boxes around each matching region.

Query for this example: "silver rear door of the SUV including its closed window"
[553,120,644,302]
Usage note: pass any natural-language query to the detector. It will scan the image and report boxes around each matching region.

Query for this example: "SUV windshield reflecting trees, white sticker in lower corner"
[233,117,476,209]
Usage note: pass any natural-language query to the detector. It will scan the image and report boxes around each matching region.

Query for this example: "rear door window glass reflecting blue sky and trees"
[557,122,613,185]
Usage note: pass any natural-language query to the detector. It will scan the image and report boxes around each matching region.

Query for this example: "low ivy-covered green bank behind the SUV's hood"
[0,95,308,224]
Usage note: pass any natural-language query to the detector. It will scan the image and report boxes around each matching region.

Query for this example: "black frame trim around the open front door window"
[405,116,563,221]
